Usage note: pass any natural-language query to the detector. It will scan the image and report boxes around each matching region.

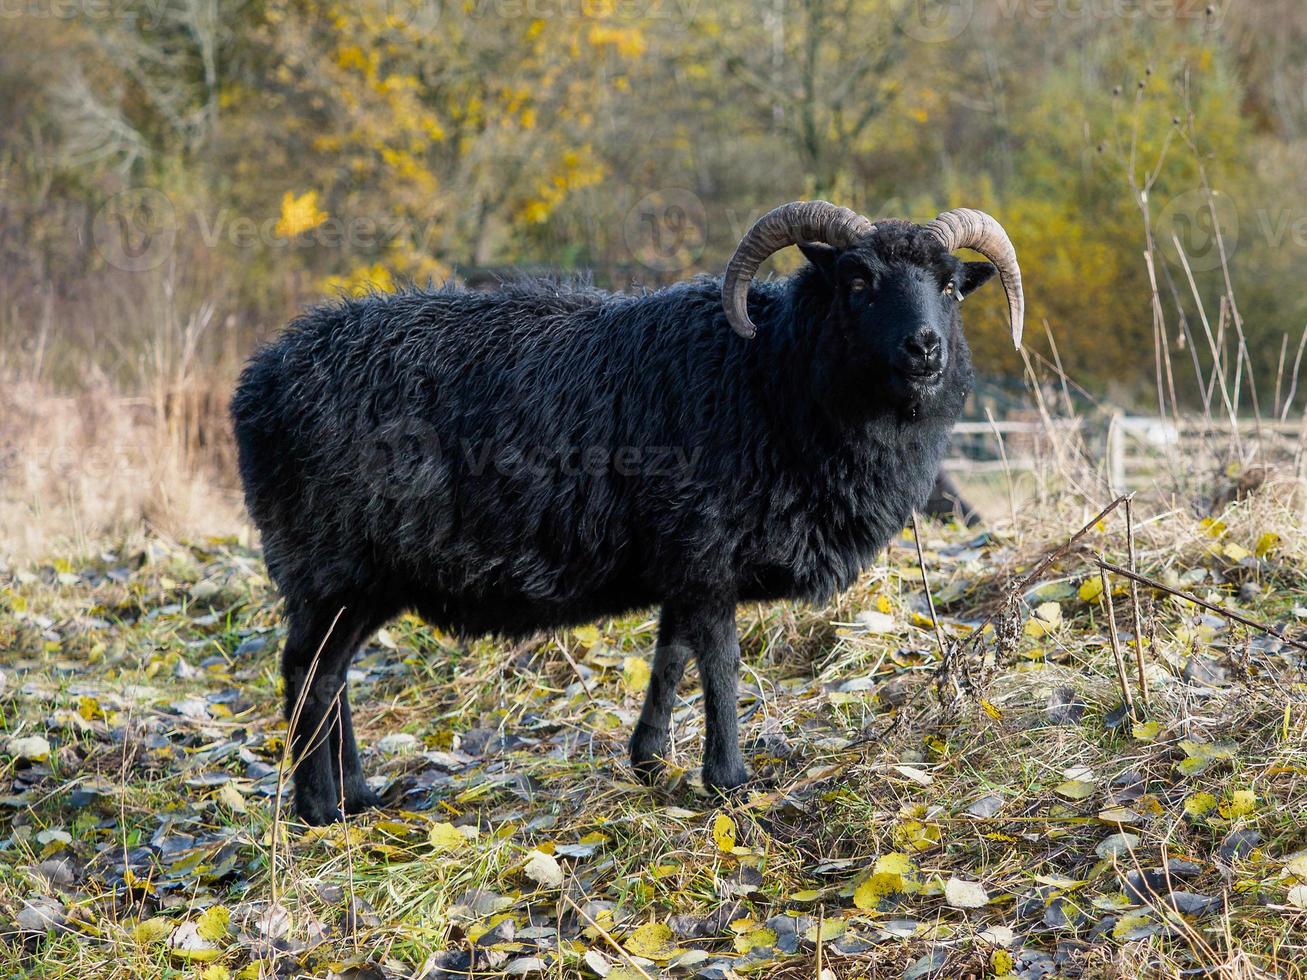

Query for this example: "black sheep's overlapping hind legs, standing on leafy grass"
[281,600,376,825]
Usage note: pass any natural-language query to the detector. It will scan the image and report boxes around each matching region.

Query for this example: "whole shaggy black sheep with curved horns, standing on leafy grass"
[233,201,1022,823]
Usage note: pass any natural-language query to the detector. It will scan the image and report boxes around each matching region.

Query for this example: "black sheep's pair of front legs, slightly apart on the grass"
[631,602,749,789]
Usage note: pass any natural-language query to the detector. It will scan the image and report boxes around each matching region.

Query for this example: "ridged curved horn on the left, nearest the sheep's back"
[721,201,876,340]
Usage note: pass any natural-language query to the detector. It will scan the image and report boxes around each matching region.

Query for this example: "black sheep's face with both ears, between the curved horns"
[802,226,996,402]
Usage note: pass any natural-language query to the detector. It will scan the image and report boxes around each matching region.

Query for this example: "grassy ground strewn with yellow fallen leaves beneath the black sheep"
[0,491,1307,980]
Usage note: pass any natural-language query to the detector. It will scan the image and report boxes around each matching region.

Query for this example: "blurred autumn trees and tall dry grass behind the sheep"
[0,0,1307,554]
